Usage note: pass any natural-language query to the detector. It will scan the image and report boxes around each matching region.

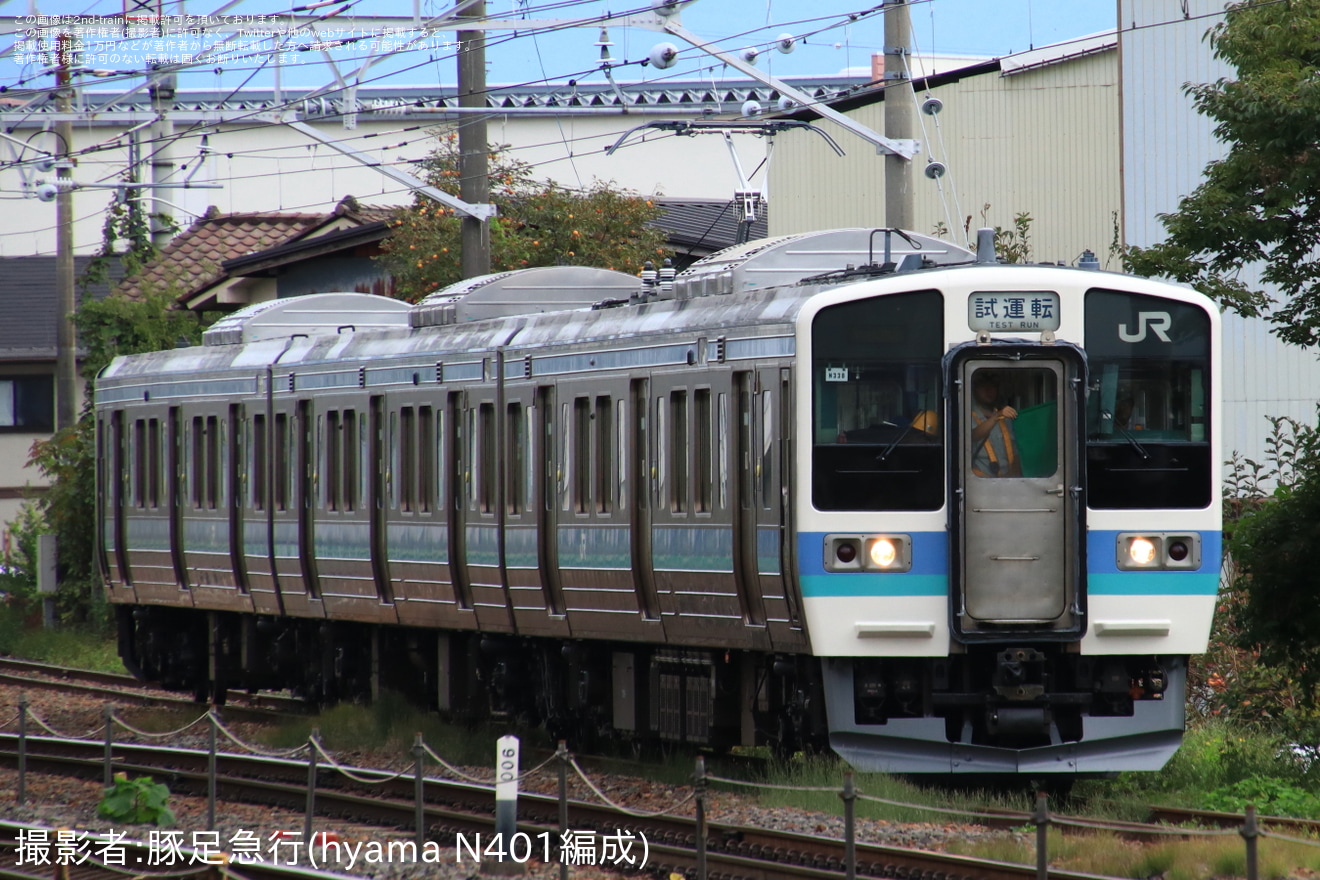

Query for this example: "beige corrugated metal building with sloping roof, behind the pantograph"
[770,34,1121,264]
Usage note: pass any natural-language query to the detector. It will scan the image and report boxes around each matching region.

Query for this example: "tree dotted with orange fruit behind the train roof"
[378,132,665,301]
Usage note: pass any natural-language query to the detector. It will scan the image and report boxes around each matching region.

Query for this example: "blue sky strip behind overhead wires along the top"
[0,0,1115,91]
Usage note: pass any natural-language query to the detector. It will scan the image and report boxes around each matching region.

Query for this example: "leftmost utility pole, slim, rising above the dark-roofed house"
[55,33,78,430]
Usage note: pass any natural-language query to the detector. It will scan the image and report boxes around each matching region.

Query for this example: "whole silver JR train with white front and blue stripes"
[95,228,1224,777]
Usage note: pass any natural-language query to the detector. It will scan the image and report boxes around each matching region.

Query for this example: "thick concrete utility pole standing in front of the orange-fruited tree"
[457,0,491,278]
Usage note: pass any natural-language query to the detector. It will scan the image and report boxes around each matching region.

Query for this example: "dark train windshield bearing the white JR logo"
[1086,290,1213,509]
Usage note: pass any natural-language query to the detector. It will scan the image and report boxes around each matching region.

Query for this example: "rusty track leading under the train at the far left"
[0,657,309,720]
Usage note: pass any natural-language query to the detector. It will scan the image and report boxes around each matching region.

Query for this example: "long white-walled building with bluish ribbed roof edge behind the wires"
[0,77,867,256]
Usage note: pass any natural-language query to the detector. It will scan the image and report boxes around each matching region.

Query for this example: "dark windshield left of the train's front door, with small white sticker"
[812,290,944,511]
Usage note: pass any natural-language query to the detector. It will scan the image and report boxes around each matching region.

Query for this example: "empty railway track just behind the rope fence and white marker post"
[0,736,1124,880]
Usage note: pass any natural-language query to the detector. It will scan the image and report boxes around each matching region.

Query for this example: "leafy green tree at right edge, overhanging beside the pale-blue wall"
[1126,0,1320,346]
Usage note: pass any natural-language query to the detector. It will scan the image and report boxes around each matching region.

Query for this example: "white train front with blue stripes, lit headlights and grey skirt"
[799,273,1220,773]
